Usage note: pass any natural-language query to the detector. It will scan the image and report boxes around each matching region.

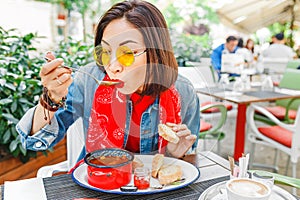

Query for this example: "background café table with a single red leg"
[196,87,300,160]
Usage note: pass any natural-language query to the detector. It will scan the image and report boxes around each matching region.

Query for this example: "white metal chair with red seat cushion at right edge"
[247,105,300,194]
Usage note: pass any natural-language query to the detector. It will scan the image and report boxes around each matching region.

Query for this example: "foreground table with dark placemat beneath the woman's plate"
[0,151,230,200]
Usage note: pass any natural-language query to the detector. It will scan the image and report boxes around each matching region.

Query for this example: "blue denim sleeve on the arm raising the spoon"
[16,74,83,151]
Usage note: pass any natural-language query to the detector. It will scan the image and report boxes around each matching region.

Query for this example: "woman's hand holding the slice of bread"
[166,122,197,158]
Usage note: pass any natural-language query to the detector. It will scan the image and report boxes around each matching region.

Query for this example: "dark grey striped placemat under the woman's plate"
[44,175,229,200]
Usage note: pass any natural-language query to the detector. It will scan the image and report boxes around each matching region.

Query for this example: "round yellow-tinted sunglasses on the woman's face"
[94,45,147,67]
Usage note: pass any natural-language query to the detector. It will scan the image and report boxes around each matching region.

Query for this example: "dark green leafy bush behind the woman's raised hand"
[0,27,93,162]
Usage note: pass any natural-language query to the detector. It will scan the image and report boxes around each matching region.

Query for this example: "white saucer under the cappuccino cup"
[198,181,297,200]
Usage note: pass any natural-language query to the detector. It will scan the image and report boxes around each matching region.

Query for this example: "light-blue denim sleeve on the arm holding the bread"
[175,75,200,153]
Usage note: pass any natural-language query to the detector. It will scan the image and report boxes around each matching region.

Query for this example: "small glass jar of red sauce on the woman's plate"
[134,167,150,190]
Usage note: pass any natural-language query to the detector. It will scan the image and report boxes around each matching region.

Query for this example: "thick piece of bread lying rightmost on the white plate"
[158,165,182,185]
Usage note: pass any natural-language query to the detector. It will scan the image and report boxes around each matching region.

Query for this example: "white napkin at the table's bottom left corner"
[4,178,47,200]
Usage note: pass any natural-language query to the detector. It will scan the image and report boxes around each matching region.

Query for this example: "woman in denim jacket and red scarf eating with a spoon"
[17,1,200,162]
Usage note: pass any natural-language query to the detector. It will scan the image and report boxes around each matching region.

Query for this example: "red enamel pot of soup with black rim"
[84,148,134,190]
